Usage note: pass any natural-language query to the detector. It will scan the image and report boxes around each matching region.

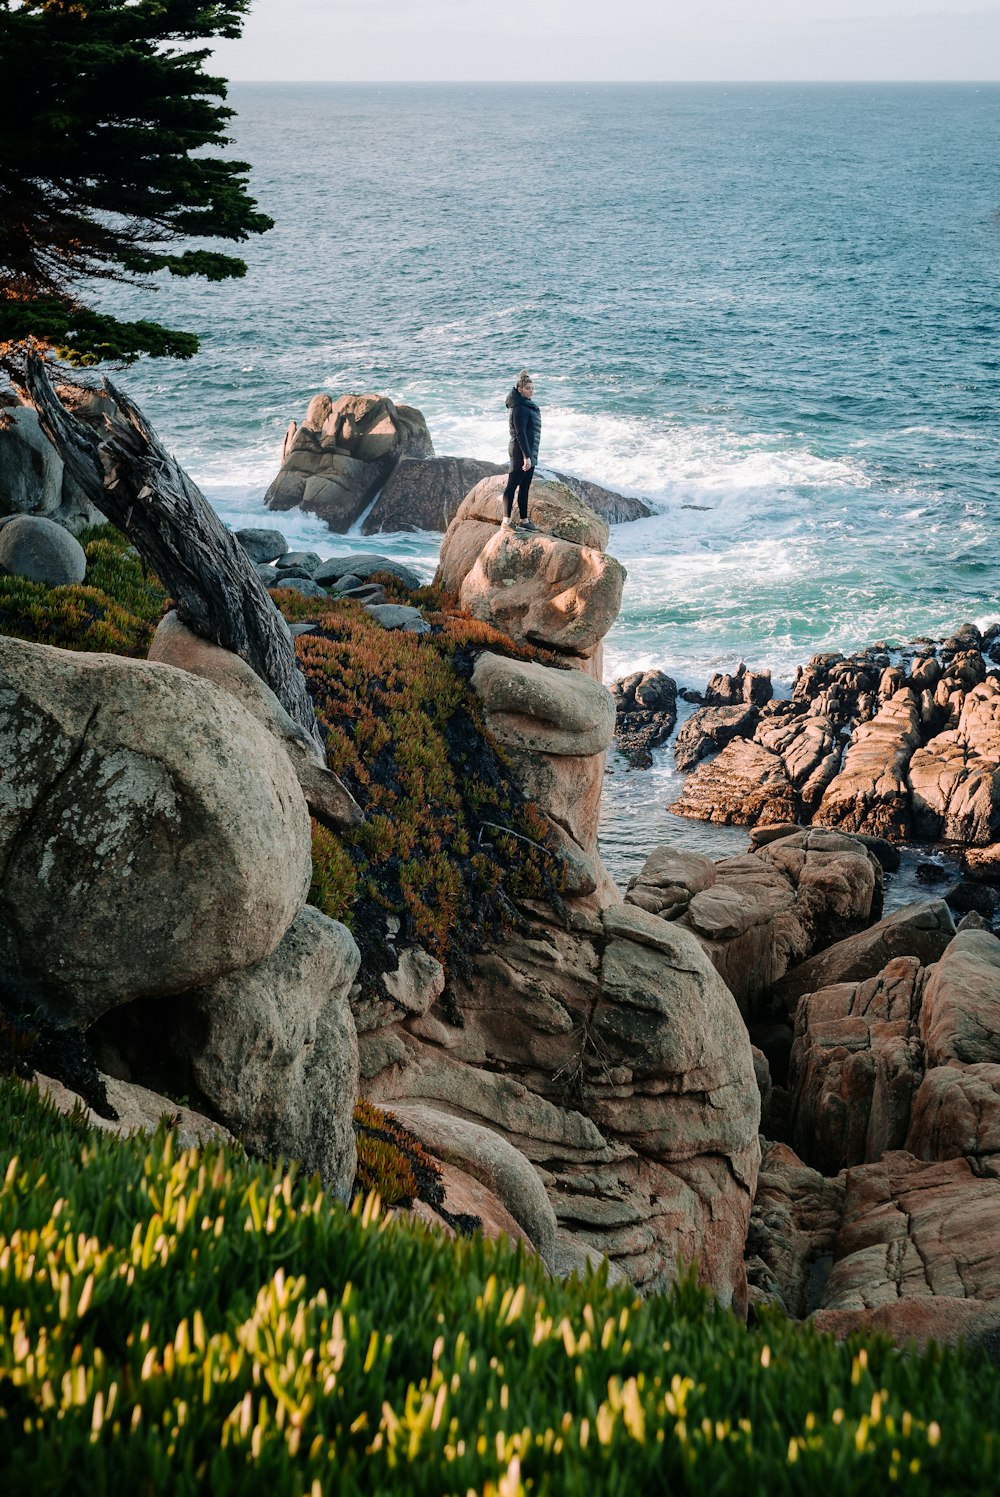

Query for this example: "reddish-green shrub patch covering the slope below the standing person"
[275,590,564,982]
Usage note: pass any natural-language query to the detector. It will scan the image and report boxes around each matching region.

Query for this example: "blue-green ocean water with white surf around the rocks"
[91,84,1000,876]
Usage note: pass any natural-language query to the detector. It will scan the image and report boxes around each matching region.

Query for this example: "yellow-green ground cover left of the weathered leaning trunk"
[0,525,166,659]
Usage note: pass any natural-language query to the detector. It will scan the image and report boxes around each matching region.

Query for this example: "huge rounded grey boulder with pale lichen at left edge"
[0,638,311,1025]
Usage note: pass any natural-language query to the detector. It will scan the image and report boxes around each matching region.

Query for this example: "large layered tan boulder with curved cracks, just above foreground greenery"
[359,906,760,1305]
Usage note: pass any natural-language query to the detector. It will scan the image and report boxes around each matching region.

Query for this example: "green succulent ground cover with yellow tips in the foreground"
[0,1081,1000,1497]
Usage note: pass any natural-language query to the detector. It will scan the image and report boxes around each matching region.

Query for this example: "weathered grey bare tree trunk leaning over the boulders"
[27,356,320,743]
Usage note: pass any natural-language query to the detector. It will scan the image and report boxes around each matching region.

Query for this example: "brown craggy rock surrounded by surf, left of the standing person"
[265,395,434,533]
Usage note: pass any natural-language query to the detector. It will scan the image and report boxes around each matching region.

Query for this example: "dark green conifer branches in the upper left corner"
[0,0,271,371]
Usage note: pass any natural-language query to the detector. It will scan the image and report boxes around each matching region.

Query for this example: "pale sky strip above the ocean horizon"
[216,0,1000,82]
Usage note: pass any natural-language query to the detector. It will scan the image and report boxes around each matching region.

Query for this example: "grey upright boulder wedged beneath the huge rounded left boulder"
[175,906,361,1199]
